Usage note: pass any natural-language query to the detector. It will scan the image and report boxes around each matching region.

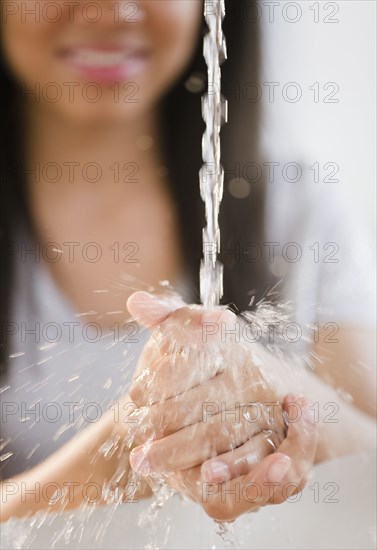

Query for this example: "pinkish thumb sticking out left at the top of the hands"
[127,291,187,328]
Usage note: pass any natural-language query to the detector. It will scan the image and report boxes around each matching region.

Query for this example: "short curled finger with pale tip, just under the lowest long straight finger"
[201,430,281,483]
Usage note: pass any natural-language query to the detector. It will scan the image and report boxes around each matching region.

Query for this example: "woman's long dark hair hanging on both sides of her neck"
[0,0,271,365]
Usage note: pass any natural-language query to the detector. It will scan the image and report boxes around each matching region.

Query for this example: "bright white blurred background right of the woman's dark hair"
[260,0,377,239]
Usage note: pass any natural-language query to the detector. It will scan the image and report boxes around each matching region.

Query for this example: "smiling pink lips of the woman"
[58,44,149,83]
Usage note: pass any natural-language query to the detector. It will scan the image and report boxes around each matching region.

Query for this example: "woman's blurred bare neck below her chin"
[26,106,163,197]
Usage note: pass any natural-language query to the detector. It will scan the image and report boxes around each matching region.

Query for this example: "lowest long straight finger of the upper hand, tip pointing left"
[130,404,284,475]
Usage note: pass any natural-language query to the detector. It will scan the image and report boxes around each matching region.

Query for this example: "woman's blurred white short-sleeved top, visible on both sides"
[0,182,375,478]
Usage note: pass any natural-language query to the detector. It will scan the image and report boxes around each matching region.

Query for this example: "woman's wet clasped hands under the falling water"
[128,292,317,520]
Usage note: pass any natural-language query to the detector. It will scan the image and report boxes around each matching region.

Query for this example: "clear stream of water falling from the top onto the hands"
[199,0,227,307]
